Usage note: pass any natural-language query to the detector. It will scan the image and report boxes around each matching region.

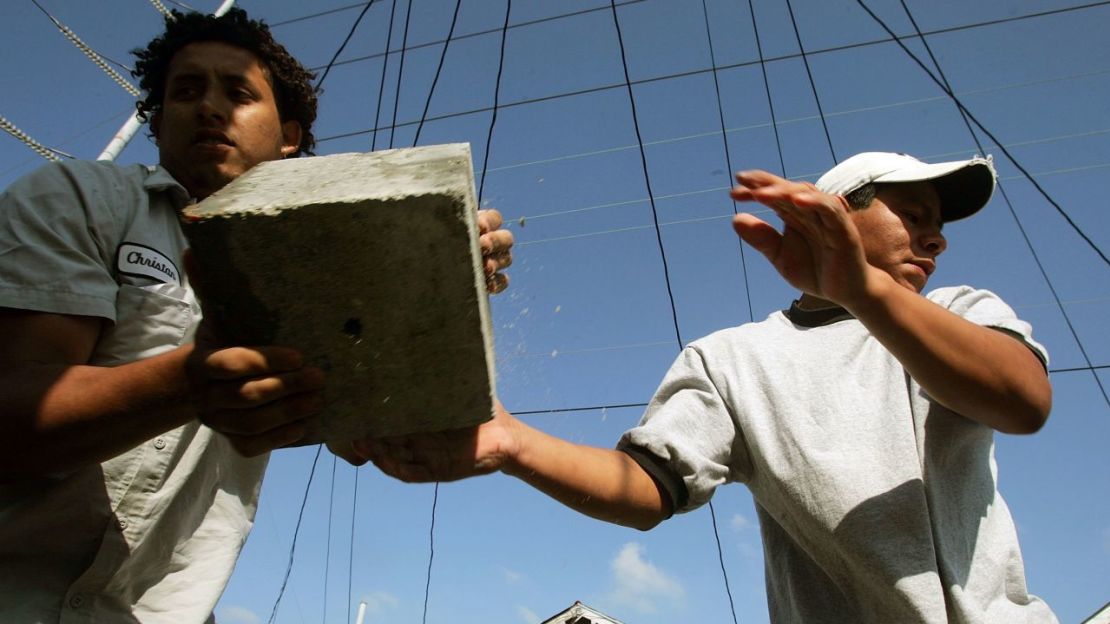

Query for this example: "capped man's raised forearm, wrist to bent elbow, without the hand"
[846,273,1051,433]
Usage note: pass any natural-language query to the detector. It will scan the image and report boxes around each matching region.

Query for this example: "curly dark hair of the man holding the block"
[131,9,316,155]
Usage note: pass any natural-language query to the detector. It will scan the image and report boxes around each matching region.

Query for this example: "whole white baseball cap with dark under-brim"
[817,152,996,222]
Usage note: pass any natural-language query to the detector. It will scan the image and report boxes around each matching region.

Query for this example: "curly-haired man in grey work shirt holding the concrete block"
[0,10,512,623]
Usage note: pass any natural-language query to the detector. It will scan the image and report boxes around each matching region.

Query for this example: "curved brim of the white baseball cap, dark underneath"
[875,158,995,223]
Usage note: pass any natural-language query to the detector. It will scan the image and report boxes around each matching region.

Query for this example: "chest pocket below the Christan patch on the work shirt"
[90,283,200,366]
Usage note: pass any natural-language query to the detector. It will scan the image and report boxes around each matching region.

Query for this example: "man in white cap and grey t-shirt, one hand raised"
[360,152,1056,624]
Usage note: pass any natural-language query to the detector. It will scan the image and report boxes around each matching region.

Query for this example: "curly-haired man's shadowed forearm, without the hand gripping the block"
[0,345,195,481]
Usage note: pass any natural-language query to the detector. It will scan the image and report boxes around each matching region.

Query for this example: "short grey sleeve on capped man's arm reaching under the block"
[617,346,748,512]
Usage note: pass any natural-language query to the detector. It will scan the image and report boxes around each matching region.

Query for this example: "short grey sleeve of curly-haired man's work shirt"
[0,162,127,321]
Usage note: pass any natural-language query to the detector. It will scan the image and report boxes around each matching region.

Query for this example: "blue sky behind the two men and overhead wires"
[0,0,1110,624]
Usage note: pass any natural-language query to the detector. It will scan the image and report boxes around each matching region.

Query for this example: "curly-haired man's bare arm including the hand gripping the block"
[0,310,322,481]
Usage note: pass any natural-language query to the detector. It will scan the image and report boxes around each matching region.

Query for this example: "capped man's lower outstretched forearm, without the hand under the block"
[502,421,672,531]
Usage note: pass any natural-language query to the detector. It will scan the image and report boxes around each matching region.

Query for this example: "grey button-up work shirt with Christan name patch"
[0,162,268,624]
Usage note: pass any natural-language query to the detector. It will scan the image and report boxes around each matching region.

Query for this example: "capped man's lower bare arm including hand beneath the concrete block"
[354,404,672,531]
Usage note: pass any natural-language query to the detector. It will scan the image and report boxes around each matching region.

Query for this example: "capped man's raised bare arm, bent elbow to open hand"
[733,171,1051,433]
